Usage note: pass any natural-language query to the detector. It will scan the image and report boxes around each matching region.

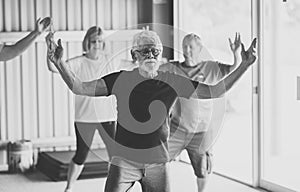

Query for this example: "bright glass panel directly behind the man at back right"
[174,0,252,183]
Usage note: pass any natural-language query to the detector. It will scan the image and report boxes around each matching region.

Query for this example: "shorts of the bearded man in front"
[105,156,170,192]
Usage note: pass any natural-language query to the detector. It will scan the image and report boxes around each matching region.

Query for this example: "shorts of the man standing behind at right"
[168,129,212,178]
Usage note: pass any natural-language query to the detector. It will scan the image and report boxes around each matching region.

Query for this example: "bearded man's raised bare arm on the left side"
[47,39,108,96]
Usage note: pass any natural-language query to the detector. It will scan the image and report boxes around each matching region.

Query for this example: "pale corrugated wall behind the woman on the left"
[0,0,137,169]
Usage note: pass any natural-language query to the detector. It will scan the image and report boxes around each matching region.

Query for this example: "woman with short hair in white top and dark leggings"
[46,26,117,192]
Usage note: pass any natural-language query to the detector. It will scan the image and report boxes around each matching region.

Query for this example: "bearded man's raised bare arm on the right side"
[196,38,256,99]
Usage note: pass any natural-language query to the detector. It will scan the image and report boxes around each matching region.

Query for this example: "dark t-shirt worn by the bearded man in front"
[103,69,198,163]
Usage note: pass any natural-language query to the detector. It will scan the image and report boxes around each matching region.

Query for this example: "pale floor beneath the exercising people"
[0,162,257,192]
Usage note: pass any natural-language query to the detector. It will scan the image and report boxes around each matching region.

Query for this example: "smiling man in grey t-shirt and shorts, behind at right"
[160,33,241,192]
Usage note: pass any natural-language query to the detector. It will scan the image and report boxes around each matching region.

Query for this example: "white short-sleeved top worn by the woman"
[67,55,117,122]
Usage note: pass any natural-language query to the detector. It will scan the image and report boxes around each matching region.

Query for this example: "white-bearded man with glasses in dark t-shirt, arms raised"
[48,31,256,192]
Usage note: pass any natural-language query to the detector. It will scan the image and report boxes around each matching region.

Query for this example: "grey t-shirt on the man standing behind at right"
[160,61,229,133]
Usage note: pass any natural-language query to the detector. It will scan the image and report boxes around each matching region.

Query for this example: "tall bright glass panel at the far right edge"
[261,0,300,191]
